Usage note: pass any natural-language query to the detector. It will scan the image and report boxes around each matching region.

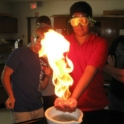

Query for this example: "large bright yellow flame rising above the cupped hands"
[39,29,73,99]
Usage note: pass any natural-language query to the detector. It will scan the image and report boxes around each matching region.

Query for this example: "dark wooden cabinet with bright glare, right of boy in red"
[101,17,124,47]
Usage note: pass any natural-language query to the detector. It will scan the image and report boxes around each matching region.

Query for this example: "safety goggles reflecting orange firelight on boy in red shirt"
[69,17,95,27]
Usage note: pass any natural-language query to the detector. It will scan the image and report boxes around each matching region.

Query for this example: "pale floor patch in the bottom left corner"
[0,108,11,124]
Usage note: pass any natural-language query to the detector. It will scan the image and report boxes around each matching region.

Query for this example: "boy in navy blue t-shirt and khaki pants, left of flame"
[1,26,52,123]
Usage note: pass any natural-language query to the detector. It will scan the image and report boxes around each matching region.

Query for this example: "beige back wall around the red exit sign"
[0,0,124,46]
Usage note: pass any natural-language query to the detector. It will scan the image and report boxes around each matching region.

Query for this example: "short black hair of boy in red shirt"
[70,1,92,18]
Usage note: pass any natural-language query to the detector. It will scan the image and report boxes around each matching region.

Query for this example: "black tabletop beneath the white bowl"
[13,110,124,124]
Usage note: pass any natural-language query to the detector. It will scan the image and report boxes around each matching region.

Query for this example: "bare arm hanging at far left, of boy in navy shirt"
[1,66,15,109]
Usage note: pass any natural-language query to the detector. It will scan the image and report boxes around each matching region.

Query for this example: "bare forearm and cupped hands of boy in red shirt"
[54,66,98,112]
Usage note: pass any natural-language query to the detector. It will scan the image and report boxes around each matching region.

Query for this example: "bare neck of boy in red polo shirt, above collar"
[75,33,90,45]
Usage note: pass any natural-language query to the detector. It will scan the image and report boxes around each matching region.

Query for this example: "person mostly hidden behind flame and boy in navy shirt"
[28,15,56,111]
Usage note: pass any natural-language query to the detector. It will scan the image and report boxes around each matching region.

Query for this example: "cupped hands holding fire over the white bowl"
[54,97,77,112]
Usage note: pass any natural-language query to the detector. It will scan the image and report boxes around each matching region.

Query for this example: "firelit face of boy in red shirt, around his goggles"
[72,13,90,37]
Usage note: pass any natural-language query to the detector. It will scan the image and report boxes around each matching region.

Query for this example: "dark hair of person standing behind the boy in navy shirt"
[36,15,51,25]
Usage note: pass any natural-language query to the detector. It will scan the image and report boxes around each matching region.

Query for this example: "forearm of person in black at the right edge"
[103,64,124,83]
